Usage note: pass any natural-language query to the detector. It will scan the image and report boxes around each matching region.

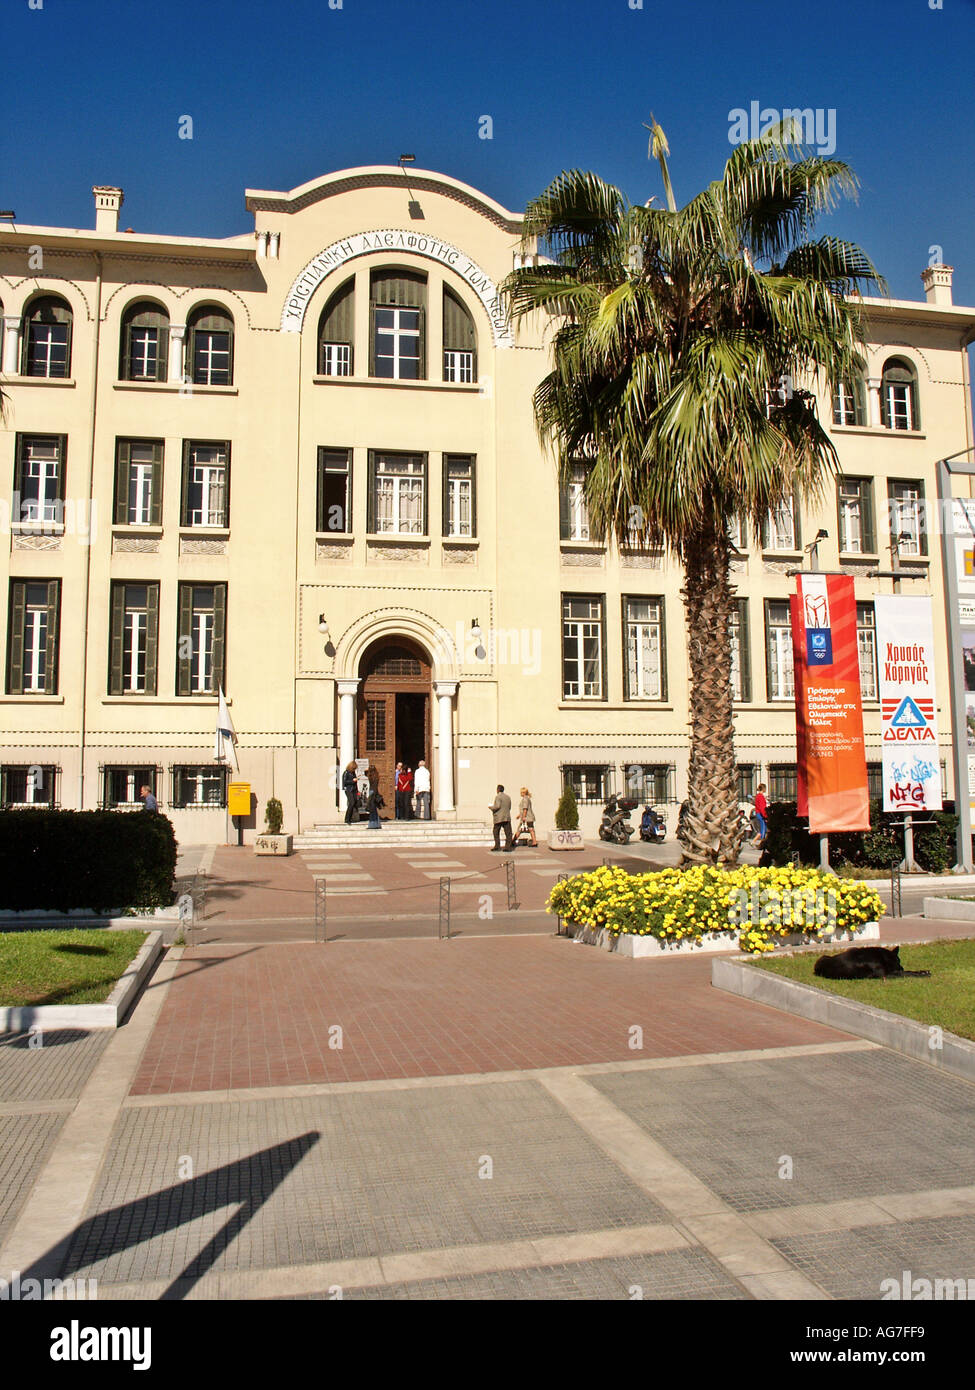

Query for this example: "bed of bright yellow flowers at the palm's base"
[547,865,883,952]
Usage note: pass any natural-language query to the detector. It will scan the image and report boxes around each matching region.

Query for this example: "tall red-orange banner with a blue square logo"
[790,574,871,834]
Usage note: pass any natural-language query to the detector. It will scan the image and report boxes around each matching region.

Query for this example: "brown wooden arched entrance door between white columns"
[356,637,433,806]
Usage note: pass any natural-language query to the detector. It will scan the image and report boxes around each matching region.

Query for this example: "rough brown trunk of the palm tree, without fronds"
[680,520,747,865]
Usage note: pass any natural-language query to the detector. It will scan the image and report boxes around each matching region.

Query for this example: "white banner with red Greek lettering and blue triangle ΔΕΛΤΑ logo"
[873,594,942,810]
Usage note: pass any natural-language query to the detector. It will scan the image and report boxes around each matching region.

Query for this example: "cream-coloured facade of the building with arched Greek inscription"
[0,168,975,842]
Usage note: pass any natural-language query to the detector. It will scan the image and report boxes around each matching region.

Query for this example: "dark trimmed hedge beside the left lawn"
[0,810,177,912]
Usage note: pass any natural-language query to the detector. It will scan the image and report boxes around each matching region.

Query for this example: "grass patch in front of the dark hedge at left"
[0,929,147,1005]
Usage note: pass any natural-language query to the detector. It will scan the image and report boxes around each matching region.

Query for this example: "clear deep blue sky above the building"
[0,0,975,304]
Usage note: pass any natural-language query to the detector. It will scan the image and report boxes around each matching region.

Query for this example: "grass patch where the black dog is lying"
[755,940,975,1038]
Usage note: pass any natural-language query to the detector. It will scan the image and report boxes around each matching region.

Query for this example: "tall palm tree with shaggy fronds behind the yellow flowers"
[503,127,879,863]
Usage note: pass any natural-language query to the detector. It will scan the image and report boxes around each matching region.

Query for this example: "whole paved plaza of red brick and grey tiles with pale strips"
[0,851,975,1301]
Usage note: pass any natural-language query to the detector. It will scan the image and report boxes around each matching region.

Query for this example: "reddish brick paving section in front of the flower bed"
[132,935,847,1094]
